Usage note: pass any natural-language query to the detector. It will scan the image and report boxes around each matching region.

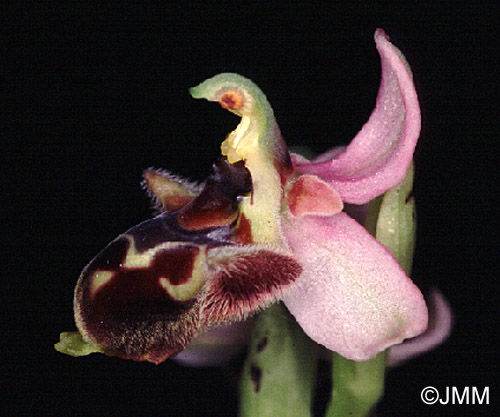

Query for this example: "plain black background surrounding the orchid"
[1,2,500,416]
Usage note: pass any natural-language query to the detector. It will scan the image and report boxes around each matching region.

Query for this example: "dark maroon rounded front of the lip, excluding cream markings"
[75,237,207,363]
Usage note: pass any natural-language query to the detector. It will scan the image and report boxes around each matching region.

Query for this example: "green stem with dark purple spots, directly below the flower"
[239,303,317,417]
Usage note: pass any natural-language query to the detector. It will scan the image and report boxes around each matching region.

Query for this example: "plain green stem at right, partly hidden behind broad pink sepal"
[326,164,416,417]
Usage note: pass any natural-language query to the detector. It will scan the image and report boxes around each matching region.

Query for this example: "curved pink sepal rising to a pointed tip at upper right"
[295,29,420,204]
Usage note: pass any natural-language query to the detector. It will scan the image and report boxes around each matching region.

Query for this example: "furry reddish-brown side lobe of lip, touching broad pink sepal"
[200,246,302,327]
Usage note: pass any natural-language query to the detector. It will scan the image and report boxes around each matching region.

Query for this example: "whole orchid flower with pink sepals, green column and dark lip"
[56,30,428,363]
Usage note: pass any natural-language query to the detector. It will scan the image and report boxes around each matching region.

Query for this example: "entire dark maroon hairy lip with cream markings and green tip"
[56,158,302,363]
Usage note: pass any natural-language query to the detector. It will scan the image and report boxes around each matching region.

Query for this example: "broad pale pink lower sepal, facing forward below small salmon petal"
[283,213,427,361]
